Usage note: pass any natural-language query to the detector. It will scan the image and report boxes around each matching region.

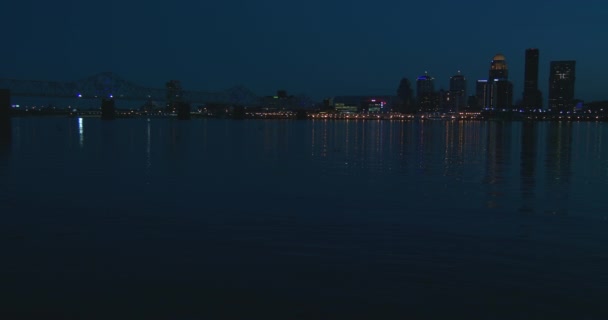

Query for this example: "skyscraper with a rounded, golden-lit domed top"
[485,53,513,109]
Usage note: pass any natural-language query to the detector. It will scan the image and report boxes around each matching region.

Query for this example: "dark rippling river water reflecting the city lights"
[0,118,608,319]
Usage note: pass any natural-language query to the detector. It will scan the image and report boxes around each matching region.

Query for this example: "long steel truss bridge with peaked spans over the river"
[0,72,260,106]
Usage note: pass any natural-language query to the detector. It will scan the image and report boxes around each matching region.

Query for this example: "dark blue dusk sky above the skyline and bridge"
[0,0,608,101]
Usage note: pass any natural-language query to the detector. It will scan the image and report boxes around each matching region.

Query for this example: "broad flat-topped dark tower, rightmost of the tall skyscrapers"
[549,60,576,111]
